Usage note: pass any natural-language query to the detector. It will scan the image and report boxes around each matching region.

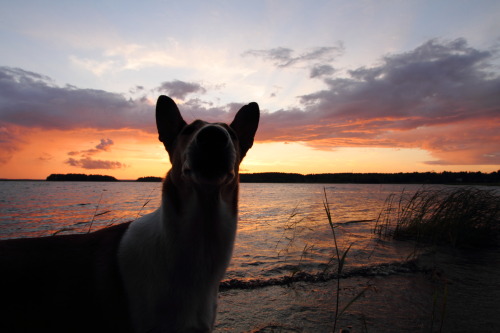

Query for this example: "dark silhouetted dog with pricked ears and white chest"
[0,96,259,333]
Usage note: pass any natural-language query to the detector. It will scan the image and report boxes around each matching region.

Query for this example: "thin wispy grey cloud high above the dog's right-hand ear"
[242,42,344,68]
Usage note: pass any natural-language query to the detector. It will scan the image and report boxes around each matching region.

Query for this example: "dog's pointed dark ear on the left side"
[156,95,186,153]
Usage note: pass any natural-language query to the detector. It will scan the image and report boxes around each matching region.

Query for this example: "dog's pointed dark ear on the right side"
[230,102,260,159]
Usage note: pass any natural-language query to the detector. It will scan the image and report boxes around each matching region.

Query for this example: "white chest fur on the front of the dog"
[119,196,237,333]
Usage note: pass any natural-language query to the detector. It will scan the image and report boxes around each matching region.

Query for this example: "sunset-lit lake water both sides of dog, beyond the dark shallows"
[0,181,442,280]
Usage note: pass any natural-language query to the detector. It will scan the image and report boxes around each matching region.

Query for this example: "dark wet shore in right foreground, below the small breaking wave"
[216,250,500,332]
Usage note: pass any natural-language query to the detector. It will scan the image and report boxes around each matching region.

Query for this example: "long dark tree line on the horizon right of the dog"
[240,170,500,184]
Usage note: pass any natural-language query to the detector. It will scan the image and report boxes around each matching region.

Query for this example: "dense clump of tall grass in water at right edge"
[374,187,500,247]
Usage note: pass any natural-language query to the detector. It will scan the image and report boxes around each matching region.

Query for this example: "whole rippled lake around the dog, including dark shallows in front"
[0,181,500,333]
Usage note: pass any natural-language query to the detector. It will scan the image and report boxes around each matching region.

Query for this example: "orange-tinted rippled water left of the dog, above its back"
[0,181,160,239]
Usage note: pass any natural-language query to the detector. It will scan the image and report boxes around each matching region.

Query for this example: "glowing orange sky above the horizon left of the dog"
[0,129,169,179]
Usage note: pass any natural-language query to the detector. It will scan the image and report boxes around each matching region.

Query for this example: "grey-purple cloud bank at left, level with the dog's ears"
[0,67,155,132]
